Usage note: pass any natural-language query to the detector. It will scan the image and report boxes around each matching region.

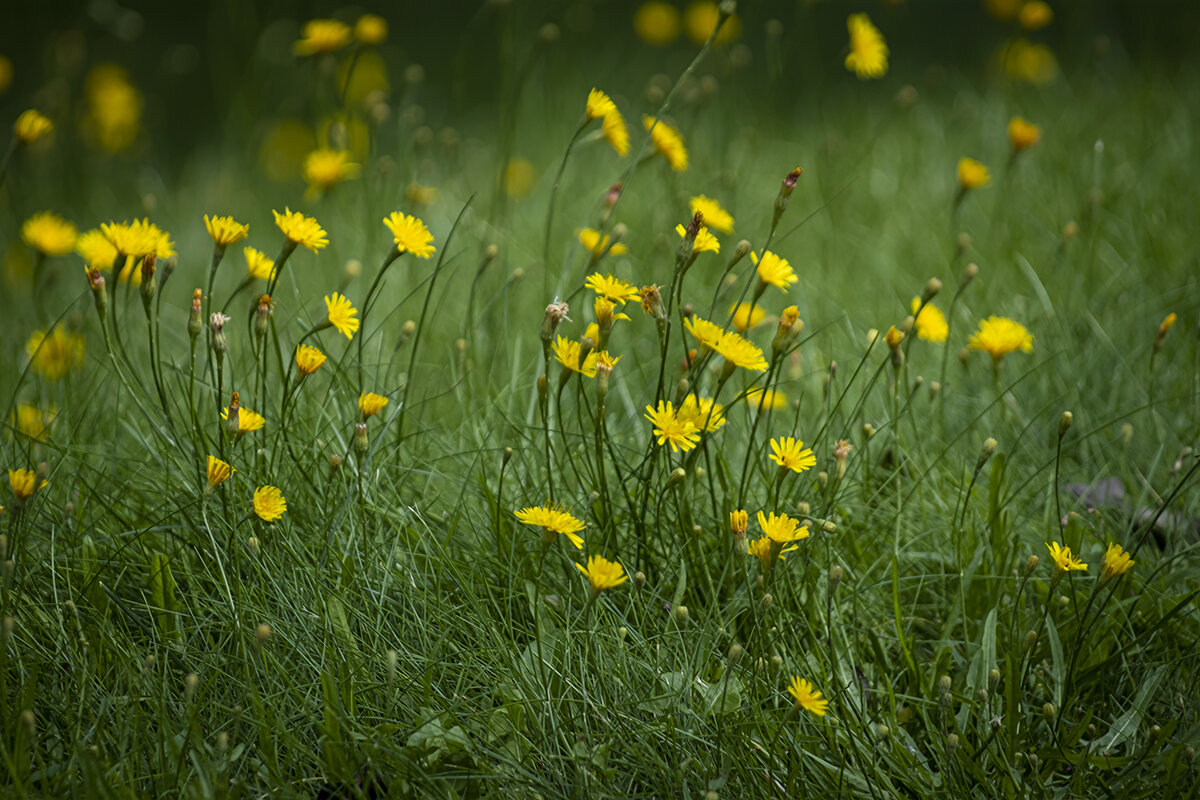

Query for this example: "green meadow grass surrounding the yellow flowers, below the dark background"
[0,3,1200,798]
